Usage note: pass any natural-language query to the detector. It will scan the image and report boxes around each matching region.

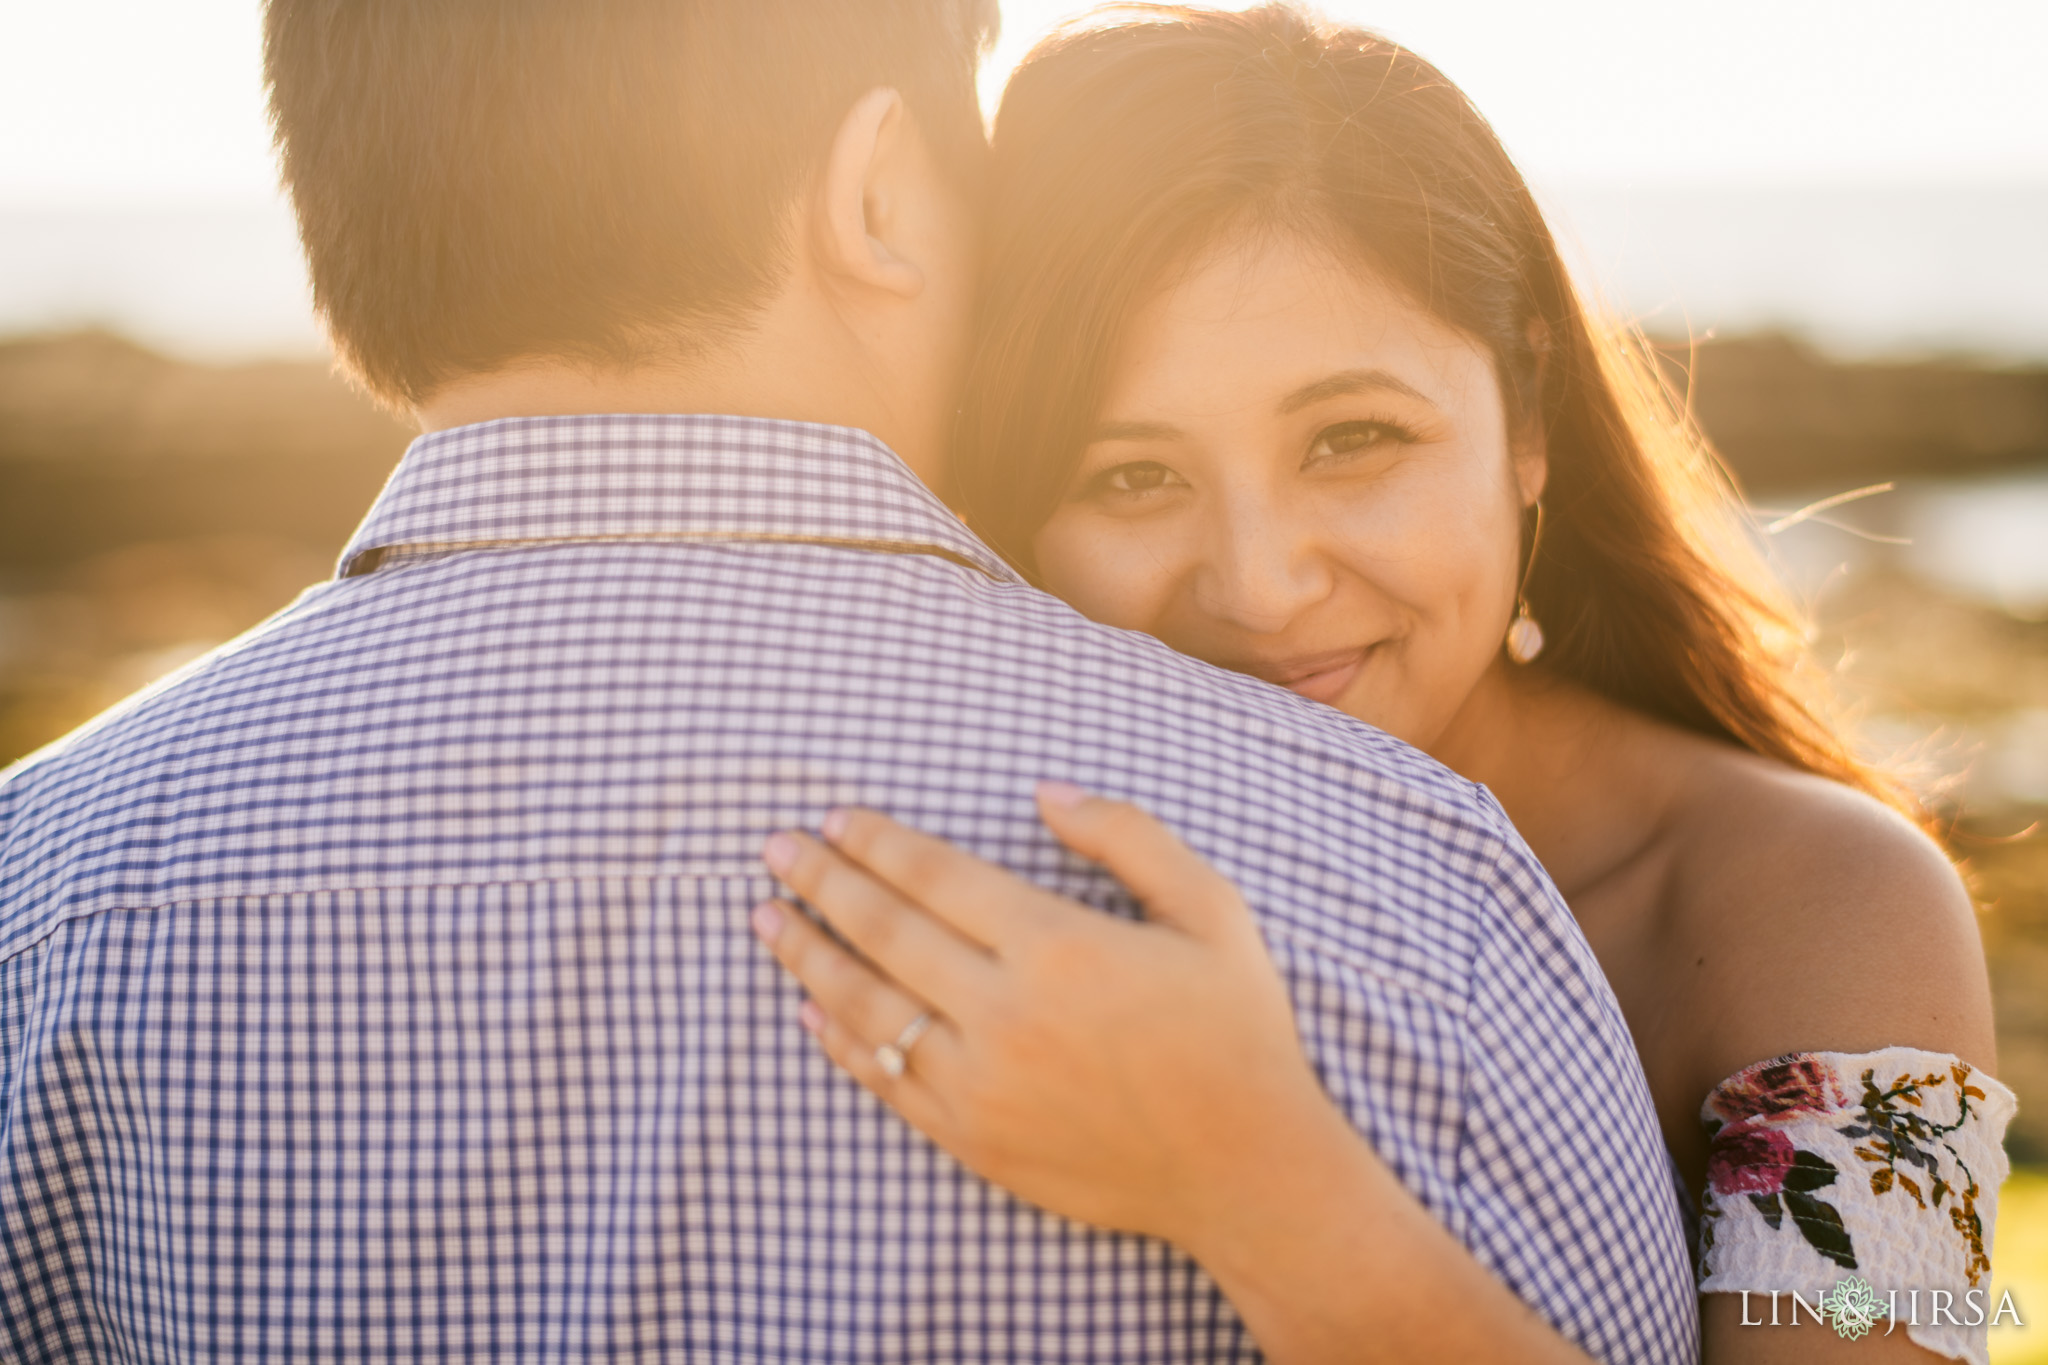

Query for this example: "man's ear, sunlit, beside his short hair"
[811,90,924,299]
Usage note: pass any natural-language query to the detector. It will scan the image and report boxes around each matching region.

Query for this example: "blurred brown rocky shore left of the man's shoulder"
[0,334,410,763]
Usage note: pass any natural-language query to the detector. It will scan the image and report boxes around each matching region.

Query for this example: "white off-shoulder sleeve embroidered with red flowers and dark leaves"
[1700,1048,2013,1365]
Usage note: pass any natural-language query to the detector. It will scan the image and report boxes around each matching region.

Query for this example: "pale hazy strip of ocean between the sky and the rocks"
[0,180,2048,364]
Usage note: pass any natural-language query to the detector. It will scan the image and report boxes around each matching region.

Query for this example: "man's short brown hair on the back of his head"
[264,0,995,405]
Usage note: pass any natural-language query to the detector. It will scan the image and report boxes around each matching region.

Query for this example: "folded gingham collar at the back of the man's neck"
[340,413,1020,583]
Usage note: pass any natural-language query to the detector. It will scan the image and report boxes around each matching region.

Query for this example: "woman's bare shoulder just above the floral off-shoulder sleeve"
[1665,751,1997,1093]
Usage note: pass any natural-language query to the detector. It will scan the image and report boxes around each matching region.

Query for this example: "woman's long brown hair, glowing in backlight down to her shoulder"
[952,4,1917,814]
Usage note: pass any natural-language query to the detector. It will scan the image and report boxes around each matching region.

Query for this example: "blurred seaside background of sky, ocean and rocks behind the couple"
[0,0,2048,1361]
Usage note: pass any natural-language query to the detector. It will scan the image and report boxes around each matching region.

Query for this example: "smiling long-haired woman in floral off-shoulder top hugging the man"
[756,8,2011,1361]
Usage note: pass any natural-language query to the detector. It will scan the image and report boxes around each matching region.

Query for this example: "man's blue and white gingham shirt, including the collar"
[0,415,1698,1365]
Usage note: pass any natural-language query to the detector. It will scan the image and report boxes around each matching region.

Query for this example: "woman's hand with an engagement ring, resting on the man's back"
[754,784,1350,1252]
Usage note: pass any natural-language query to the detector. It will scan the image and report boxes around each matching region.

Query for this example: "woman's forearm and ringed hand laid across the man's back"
[754,784,1587,1365]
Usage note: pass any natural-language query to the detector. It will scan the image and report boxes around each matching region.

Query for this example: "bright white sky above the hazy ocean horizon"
[12,0,2048,205]
